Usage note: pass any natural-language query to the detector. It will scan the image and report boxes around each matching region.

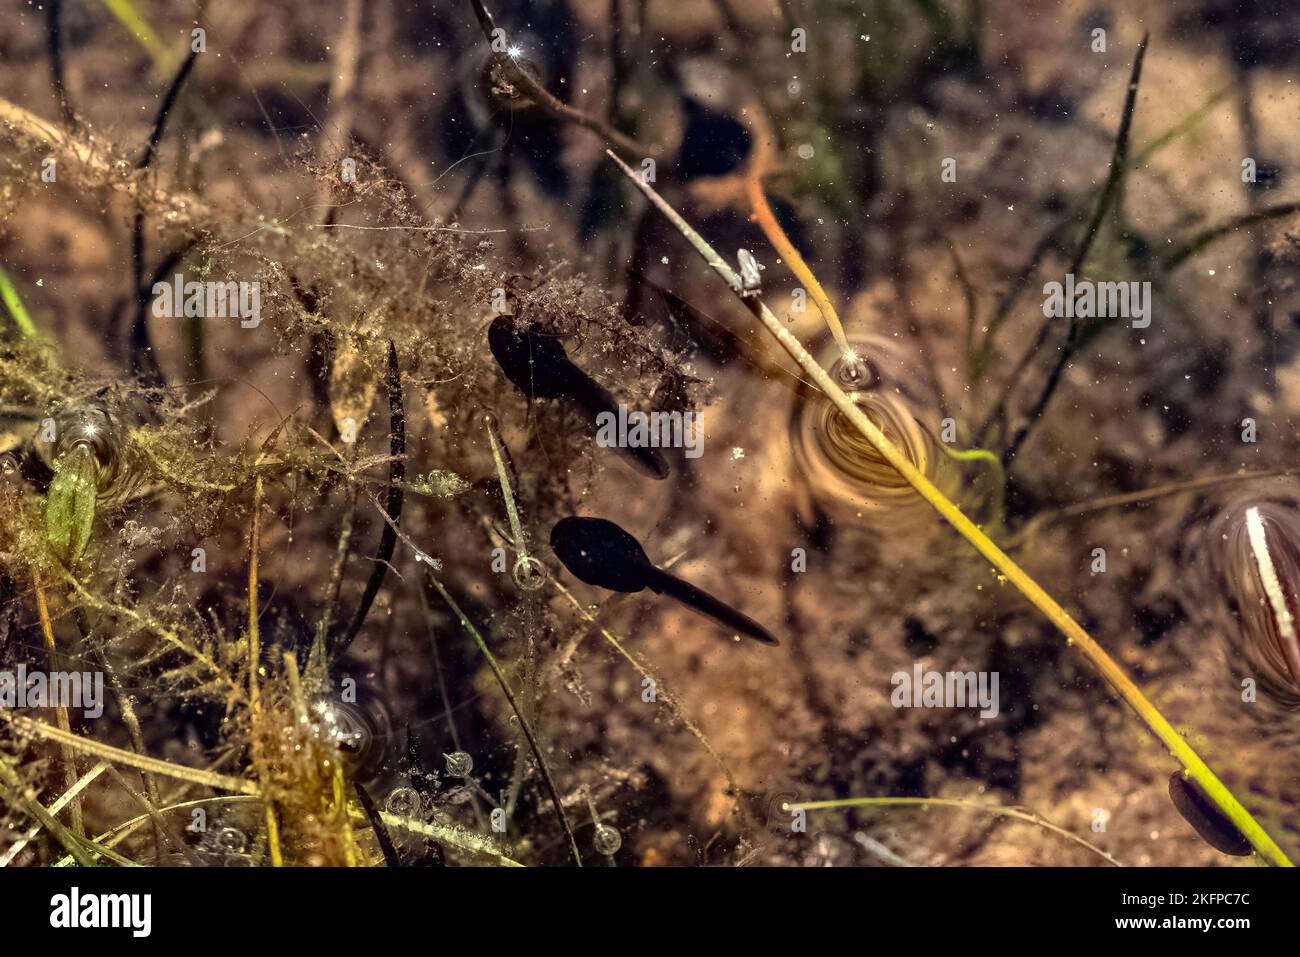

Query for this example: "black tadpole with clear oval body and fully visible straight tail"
[551,516,780,645]
